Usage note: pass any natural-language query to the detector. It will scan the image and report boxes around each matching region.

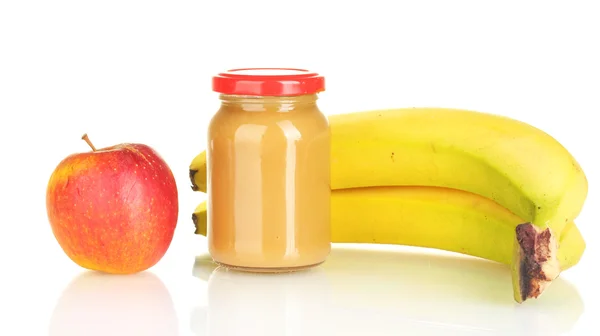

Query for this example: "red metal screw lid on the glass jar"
[212,68,325,96]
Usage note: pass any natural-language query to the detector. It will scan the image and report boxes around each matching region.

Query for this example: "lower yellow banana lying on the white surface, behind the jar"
[193,186,586,302]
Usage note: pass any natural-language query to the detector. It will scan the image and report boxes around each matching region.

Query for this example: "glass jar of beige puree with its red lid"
[207,68,331,272]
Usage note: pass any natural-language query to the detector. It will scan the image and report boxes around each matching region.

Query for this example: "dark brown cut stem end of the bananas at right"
[515,223,560,301]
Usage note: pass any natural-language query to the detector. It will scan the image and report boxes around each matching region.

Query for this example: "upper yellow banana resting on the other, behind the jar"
[190,108,588,234]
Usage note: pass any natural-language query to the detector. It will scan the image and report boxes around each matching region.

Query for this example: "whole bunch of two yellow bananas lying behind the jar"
[190,108,587,303]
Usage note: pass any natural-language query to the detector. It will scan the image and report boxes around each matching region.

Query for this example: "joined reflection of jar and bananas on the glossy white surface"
[192,248,583,336]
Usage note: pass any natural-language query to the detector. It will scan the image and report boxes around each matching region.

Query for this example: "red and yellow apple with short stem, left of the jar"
[46,135,179,274]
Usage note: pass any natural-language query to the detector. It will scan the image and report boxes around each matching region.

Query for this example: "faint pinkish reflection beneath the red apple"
[50,271,178,336]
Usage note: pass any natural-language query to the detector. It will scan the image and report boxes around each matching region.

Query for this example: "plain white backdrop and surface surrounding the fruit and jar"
[0,0,600,336]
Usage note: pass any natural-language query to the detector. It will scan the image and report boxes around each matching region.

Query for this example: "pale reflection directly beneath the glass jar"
[192,267,330,336]
